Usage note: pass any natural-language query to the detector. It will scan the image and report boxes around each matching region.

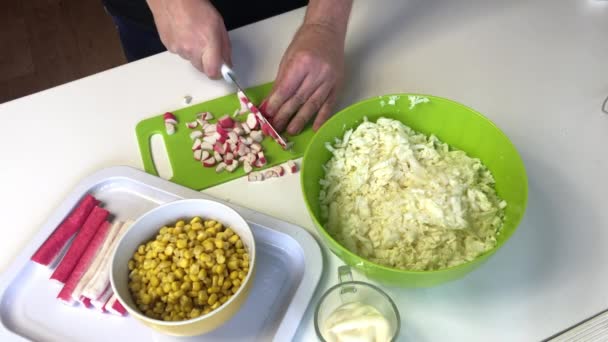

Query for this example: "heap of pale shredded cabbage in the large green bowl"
[319,118,507,270]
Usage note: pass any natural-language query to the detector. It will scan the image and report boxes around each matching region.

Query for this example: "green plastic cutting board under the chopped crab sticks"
[135,83,314,190]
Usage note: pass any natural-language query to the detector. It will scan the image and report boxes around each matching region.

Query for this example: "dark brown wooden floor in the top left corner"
[0,0,126,103]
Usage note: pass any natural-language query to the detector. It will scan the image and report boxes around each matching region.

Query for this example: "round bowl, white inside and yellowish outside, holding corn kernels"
[110,199,256,336]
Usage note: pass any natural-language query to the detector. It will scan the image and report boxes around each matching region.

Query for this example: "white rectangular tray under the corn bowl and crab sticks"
[0,167,323,342]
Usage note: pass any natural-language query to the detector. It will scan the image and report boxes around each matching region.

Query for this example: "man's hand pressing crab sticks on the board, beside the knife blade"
[263,0,352,135]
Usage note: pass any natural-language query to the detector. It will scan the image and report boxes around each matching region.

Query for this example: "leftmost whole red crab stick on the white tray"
[32,194,99,266]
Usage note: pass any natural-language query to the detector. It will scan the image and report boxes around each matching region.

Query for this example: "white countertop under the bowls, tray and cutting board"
[0,0,608,341]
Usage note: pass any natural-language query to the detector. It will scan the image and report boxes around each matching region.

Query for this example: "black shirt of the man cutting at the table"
[102,0,308,30]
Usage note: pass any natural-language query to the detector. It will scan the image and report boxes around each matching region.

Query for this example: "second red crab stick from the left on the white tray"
[51,206,109,284]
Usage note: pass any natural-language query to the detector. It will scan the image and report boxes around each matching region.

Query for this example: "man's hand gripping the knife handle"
[148,0,232,79]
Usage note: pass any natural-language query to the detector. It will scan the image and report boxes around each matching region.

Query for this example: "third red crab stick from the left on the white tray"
[57,221,110,302]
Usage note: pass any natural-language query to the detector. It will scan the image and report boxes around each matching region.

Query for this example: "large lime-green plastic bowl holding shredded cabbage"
[300,94,528,287]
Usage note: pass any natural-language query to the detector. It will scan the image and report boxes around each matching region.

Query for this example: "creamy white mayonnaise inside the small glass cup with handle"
[322,302,392,342]
